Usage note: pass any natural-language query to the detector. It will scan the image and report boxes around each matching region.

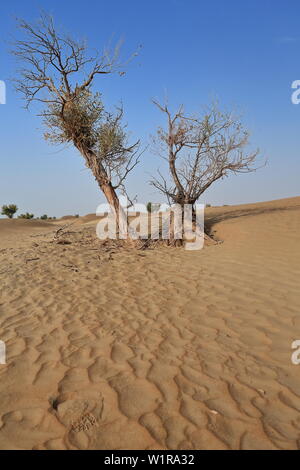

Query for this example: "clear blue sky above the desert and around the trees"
[0,0,300,216]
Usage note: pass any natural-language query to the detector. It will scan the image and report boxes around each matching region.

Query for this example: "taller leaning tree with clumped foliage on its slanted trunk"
[12,15,140,237]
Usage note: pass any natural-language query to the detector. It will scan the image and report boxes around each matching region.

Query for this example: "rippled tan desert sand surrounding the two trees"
[0,198,300,449]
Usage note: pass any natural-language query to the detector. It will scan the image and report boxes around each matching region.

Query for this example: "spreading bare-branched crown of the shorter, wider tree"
[150,101,258,244]
